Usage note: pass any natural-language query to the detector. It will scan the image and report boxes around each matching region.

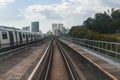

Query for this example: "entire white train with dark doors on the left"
[0,26,44,50]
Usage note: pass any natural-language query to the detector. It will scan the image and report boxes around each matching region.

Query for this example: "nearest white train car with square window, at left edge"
[0,26,17,48]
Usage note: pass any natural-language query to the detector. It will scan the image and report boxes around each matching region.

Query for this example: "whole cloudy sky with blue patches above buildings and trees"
[0,0,120,33]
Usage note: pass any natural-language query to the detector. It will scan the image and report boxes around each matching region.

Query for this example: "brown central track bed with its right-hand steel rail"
[46,40,77,80]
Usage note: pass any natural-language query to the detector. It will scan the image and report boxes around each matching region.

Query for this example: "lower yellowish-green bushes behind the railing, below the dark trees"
[69,26,119,42]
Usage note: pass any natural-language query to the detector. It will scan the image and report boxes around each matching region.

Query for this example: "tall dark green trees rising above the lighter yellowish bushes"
[83,8,120,33]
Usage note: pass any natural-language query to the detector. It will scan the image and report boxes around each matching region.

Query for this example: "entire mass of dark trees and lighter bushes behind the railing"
[69,8,120,42]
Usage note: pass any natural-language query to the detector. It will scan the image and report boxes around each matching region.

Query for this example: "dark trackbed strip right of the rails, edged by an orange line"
[60,41,118,80]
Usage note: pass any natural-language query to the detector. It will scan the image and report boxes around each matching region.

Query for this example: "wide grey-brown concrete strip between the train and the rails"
[0,43,47,80]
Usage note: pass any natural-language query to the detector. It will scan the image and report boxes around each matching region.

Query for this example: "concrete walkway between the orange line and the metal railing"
[60,39,120,80]
